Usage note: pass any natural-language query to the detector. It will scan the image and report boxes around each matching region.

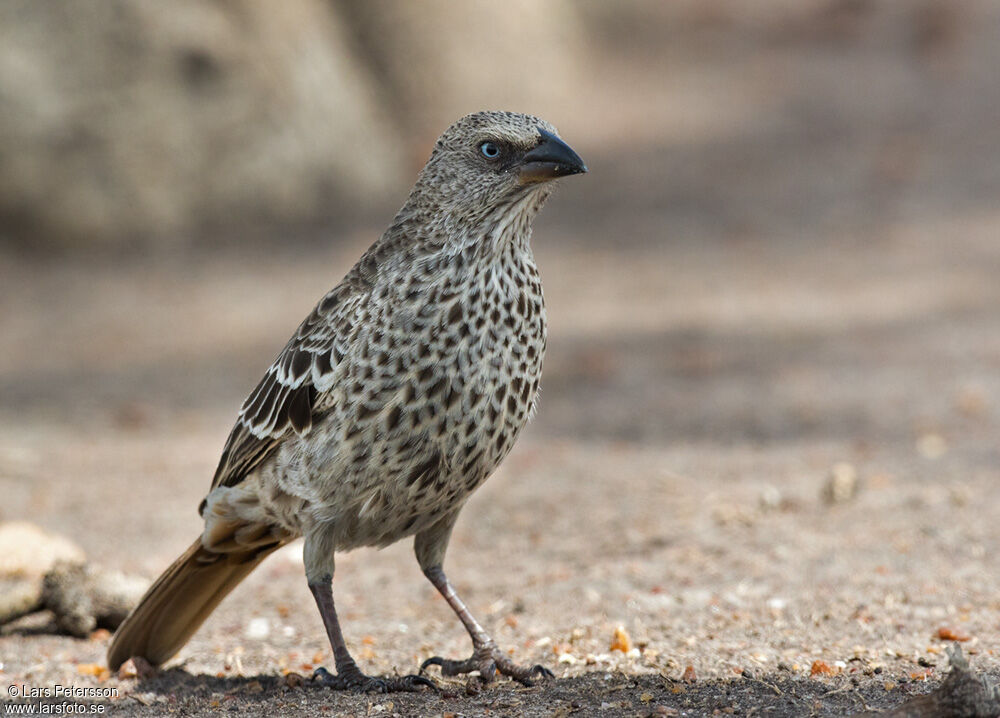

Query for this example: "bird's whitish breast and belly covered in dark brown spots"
[285,243,546,548]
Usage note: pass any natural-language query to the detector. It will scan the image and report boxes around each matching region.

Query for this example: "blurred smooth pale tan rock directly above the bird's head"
[324,0,587,148]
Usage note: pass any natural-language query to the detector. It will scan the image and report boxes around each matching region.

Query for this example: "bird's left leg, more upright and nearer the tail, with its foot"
[304,536,437,693]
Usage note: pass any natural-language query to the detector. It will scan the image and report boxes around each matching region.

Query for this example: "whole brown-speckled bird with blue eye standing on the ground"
[107,111,587,692]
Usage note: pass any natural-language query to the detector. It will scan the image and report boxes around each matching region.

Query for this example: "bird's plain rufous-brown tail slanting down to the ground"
[108,539,282,671]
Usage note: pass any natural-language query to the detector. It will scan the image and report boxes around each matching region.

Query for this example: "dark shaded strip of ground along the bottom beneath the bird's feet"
[94,668,931,717]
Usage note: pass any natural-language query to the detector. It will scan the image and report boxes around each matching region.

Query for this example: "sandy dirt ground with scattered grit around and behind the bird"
[0,4,1000,716]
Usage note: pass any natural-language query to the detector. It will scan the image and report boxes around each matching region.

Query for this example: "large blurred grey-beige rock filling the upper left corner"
[0,0,401,245]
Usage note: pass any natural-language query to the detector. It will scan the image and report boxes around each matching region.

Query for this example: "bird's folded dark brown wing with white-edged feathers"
[212,282,363,496]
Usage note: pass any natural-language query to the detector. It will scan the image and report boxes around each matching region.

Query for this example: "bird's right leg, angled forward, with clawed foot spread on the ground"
[414,511,553,686]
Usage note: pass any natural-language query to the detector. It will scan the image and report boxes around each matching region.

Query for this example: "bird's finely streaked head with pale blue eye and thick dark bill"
[411,112,587,232]
